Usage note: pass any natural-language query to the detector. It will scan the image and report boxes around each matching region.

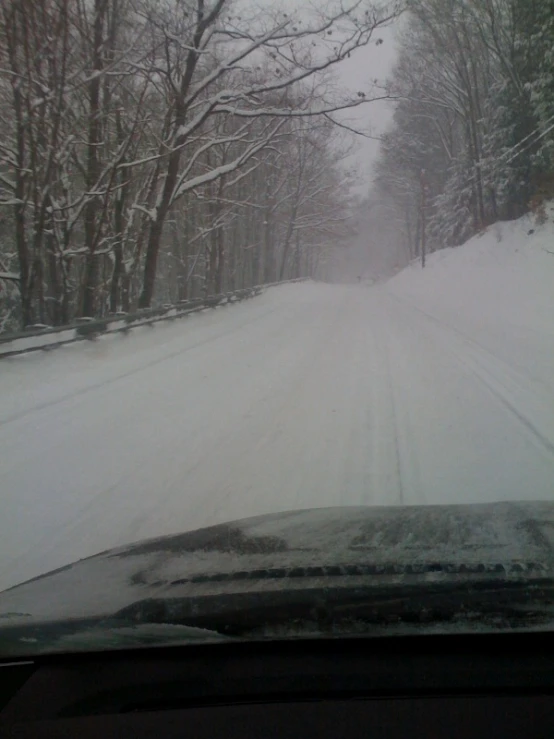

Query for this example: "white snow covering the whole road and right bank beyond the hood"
[0,212,554,589]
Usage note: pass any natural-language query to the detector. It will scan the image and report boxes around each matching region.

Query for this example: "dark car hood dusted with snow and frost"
[0,502,554,627]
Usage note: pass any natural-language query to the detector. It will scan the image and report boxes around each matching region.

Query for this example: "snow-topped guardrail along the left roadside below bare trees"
[0,277,307,359]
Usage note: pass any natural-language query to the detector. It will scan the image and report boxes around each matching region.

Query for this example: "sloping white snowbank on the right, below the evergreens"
[386,205,554,390]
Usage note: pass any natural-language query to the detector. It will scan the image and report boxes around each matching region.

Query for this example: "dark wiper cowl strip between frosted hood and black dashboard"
[0,578,554,656]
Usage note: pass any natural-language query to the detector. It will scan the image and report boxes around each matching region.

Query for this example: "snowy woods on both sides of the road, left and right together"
[0,0,554,331]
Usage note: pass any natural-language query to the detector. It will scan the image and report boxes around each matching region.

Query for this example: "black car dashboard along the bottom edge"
[0,633,554,739]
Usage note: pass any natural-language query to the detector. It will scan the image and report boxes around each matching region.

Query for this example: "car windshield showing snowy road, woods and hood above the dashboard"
[0,0,554,657]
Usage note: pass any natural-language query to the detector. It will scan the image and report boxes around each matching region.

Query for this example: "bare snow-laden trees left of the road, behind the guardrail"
[0,0,392,331]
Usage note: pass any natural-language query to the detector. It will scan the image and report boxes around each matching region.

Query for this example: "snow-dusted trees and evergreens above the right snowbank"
[366,0,554,262]
